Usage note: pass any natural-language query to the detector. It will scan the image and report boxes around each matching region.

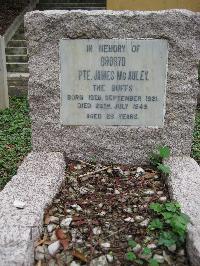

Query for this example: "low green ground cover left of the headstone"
[0,97,31,189]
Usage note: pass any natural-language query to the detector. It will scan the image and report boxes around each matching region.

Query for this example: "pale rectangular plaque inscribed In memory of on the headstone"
[60,39,168,127]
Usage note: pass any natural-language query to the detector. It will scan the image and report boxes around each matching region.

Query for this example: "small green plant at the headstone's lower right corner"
[150,146,171,175]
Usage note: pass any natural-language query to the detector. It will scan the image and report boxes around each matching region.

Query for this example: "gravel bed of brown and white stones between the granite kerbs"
[35,162,188,266]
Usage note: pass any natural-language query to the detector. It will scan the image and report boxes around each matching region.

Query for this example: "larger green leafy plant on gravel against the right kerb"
[148,202,189,247]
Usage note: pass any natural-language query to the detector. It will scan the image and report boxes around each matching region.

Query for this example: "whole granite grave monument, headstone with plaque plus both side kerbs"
[0,10,200,266]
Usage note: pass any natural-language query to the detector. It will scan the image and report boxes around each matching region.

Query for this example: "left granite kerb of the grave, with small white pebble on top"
[0,152,65,266]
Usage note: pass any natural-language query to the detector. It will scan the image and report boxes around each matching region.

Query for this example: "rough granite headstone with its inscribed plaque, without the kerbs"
[26,10,200,164]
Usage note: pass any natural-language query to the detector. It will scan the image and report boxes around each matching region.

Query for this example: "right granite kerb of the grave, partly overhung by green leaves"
[167,157,200,266]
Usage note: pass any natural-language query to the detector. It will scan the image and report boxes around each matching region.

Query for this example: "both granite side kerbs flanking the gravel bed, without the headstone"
[0,152,200,266]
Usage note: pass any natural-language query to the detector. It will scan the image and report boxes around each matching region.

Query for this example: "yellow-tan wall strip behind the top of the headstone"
[107,0,200,11]
